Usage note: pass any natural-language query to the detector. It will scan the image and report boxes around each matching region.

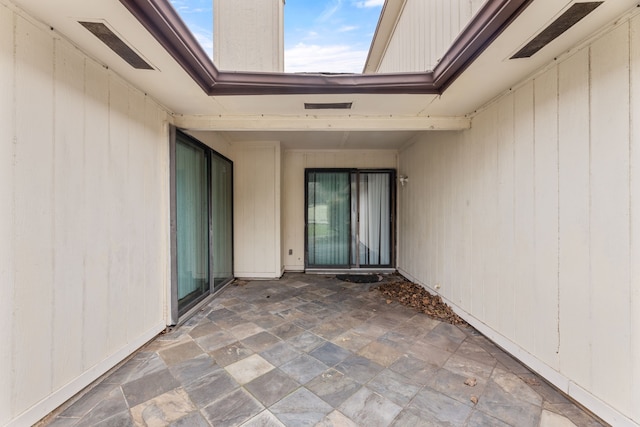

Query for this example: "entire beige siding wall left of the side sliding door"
[0,3,168,425]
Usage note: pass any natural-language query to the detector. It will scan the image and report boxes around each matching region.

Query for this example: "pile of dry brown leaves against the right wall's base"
[376,279,467,325]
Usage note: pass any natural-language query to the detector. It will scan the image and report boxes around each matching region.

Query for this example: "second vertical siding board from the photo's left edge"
[10,17,54,415]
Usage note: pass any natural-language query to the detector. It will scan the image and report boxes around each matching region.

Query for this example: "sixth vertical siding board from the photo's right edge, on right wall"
[496,94,516,339]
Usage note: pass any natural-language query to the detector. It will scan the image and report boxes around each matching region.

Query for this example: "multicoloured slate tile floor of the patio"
[43,274,602,427]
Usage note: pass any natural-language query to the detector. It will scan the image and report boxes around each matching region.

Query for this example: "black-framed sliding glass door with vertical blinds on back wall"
[305,169,395,268]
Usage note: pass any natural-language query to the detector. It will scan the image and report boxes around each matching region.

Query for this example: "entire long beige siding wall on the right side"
[399,14,640,425]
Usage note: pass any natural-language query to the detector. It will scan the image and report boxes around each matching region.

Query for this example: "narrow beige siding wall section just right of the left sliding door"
[233,142,282,278]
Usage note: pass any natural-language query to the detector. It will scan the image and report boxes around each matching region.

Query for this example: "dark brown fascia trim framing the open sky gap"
[120,0,533,96]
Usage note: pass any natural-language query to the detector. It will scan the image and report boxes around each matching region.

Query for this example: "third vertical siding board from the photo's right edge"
[558,49,592,387]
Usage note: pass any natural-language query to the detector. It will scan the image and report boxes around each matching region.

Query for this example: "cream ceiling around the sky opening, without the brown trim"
[12,0,637,149]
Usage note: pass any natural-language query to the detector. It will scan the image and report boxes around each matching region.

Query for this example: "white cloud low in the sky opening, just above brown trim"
[284,43,369,73]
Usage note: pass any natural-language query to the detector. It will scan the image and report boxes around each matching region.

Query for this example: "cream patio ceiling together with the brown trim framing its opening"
[14,0,636,149]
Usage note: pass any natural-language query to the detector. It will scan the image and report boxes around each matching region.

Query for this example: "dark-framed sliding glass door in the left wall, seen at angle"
[171,130,233,323]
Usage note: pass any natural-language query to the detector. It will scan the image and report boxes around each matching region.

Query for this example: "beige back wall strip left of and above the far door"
[282,150,398,271]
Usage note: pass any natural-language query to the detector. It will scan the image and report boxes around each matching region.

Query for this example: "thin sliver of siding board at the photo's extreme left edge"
[0,5,16,425]
